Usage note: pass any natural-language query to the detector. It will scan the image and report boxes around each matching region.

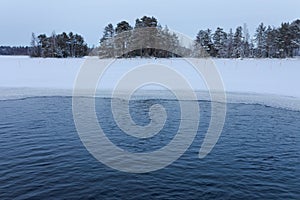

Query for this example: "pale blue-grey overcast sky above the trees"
[0,0,300,46]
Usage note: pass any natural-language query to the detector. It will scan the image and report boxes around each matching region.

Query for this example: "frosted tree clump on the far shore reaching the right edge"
[195,19,300,58]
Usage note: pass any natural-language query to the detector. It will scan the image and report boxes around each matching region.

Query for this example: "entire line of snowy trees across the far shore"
[0,16,300,58]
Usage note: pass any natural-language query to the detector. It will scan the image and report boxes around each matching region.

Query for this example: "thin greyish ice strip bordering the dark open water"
[0,88,300,111]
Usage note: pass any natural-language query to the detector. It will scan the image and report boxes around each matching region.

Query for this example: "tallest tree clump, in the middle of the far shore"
[97,16,185,58]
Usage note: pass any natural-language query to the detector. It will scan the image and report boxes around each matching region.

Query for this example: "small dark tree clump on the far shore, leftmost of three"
[29,32,89,58]
